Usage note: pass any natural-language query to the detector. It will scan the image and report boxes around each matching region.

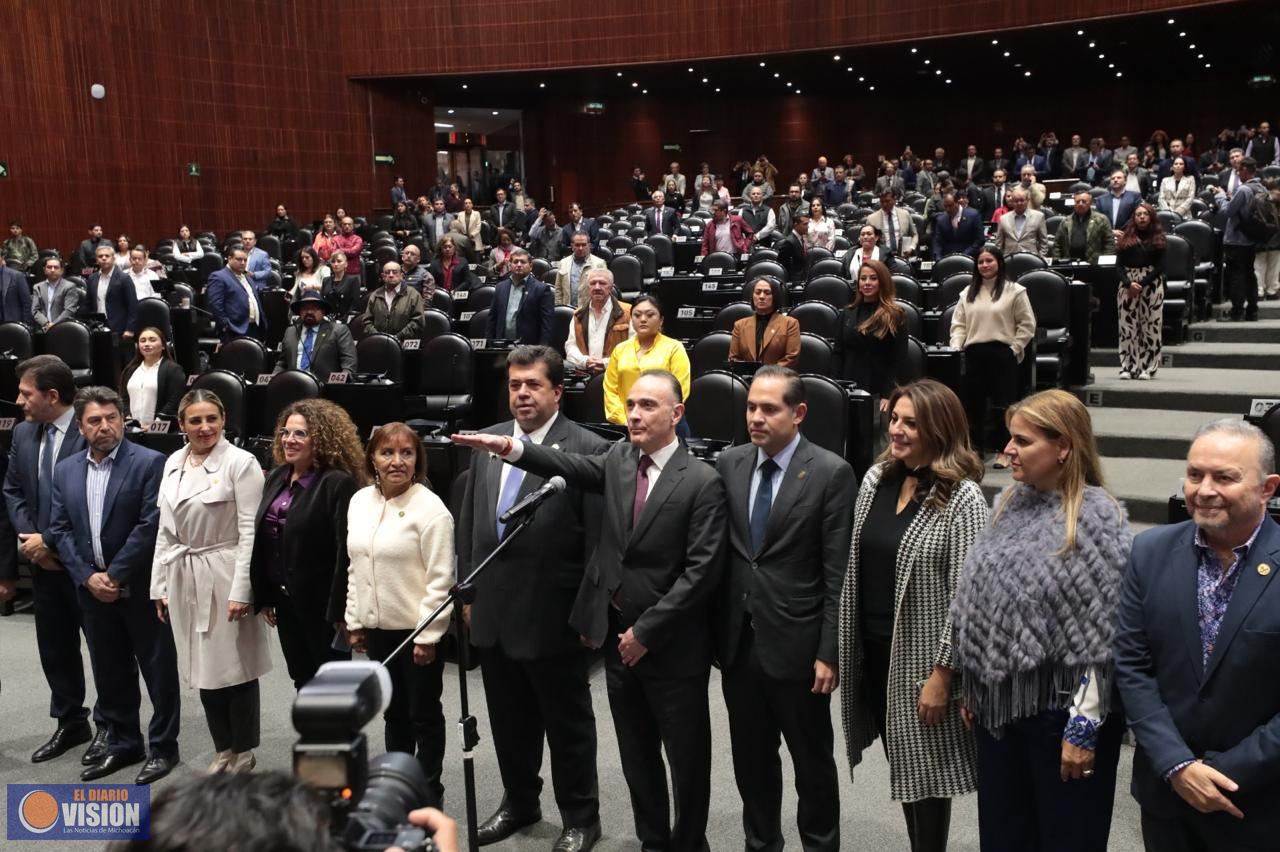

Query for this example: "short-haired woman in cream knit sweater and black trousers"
[346,423,453,806]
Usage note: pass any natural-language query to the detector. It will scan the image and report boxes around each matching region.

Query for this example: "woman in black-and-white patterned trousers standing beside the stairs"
[1116,203,1165,379]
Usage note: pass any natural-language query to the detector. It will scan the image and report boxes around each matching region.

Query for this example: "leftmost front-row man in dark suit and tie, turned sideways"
[4,356,106,764]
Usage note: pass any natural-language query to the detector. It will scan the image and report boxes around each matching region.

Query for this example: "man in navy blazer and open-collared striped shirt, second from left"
[49,388,179,784]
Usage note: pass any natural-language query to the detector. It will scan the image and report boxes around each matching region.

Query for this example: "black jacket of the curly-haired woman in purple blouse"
[248,464,356,623]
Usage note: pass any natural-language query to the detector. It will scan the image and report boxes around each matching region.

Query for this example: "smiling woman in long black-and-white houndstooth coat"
[840,379,988,852]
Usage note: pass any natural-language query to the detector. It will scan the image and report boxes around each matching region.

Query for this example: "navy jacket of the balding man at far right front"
[1115,518,1280,848]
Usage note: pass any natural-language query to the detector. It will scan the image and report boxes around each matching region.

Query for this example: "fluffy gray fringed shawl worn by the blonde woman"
[951,484,1133,730]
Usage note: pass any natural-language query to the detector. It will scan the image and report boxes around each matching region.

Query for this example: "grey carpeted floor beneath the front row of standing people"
[0,613,1142,852]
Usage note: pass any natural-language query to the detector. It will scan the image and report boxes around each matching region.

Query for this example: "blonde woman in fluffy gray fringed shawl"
[951,390,1132,852]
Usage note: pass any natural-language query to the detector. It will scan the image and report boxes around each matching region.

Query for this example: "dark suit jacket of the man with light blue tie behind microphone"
[456,413,609,660]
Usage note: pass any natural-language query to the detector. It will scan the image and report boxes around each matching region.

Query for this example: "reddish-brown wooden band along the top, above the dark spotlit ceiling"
[344,0,1204,77]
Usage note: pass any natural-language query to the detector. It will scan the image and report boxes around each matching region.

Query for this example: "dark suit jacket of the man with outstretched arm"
[517,443,726,677]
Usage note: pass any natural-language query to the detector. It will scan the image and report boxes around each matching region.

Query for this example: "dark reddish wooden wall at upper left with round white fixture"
[0,0,372,251]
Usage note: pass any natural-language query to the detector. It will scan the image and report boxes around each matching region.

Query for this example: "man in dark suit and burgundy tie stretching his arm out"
[453,370,727,852]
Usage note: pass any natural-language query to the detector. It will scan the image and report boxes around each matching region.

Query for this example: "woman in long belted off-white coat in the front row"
[151,390,271,773]
